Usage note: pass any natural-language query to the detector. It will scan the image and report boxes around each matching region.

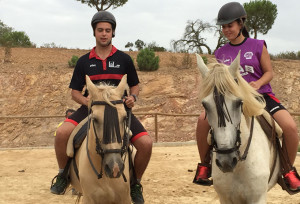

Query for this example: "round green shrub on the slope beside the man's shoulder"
[136,48,159,71]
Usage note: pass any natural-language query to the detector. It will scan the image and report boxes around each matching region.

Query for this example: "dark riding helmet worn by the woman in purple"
[217,2,247,25]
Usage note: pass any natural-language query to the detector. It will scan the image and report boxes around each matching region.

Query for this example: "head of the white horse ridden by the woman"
[196,53,243,172]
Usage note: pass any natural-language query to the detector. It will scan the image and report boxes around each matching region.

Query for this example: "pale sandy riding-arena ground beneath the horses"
[0,145,300,204]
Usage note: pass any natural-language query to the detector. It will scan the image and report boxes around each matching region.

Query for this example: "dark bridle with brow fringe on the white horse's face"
[210,88,254,161]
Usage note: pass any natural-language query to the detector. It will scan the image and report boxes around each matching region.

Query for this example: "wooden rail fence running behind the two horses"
[0,112,300,142]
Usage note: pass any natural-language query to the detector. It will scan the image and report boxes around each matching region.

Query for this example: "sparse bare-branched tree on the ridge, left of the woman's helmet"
[171,19,214,54]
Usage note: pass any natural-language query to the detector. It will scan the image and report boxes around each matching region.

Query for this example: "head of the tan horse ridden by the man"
[86,75,129,178]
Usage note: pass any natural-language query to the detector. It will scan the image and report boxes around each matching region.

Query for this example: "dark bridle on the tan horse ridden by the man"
[86,100,131,182]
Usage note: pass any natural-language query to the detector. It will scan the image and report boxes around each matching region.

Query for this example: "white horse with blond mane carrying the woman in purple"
[196,53,280,204]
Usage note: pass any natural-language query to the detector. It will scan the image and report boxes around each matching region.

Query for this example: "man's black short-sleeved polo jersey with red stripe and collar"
[69,46,139,91]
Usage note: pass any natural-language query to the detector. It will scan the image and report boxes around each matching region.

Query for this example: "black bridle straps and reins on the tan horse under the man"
[86,100,131,182]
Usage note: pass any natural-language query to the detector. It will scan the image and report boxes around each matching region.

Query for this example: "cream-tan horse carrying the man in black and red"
[67,75,131,204]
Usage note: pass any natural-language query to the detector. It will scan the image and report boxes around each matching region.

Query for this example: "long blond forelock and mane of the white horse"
[200,63,265,116]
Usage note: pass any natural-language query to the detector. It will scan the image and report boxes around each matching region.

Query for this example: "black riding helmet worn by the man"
[91,11,117,37]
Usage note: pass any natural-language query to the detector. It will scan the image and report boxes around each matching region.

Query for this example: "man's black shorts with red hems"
[65,105,148,142]
